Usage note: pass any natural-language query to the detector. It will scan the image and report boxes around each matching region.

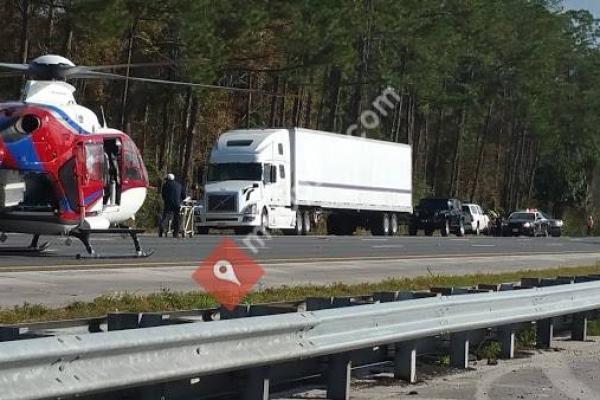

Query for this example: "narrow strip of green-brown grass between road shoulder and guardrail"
[0,264,600,326]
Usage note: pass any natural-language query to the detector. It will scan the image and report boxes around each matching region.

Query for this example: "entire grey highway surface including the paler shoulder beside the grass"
[0,235,600,307]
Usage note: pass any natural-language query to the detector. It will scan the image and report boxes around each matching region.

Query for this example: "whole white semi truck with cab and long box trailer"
[196,128,412,235]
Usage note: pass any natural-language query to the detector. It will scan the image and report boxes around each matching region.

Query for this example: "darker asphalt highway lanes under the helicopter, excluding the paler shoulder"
[0,235,600,271]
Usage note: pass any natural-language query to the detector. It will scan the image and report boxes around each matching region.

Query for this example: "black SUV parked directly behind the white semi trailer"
[408,198,465,236]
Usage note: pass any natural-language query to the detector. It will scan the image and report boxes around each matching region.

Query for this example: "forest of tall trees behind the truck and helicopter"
[0,0,600,222]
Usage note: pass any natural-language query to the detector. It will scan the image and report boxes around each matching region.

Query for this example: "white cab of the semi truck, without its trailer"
[197,129,296,233]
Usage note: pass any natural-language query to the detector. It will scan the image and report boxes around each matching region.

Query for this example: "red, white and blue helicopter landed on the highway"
[0,54,264,258]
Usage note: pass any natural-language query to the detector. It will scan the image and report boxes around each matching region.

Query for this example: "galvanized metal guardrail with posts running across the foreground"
[0,276,600,400]
